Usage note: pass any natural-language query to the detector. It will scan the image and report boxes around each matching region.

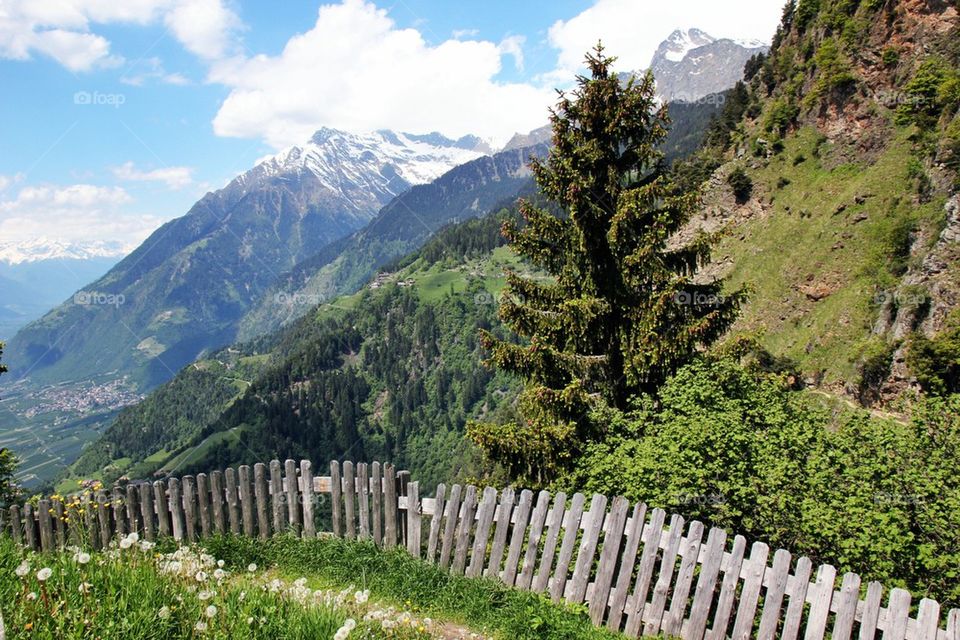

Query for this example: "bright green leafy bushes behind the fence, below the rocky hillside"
[562,360,960,606]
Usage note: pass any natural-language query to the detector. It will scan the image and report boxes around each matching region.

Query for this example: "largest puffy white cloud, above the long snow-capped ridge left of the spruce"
[210,0,554,147]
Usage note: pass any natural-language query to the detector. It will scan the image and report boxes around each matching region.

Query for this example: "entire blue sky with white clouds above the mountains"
[0,0,781,248]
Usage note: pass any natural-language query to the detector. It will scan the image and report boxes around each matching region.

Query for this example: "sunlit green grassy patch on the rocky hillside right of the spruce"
[714,122,944,388]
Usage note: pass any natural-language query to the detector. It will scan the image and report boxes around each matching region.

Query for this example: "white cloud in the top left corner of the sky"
[0,0,241,72]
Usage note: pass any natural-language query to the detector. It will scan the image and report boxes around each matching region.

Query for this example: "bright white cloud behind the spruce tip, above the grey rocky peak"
[548,0,784,79]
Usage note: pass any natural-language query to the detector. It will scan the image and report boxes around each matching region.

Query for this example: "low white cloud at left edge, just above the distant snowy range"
[0,184,163,248]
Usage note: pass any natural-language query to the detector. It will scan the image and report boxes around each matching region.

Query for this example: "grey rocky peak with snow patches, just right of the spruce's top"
[650,29,768,102]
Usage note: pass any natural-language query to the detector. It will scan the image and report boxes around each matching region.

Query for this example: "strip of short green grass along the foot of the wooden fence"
[203,537,623,640]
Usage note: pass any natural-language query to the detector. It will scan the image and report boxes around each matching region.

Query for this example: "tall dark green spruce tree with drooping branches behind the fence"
[469,45,742,485]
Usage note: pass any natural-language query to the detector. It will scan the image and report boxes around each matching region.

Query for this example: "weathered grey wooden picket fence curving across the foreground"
[3,460,960,640]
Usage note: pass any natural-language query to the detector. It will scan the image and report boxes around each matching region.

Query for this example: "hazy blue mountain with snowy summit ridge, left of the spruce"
[4,129,483,388]
